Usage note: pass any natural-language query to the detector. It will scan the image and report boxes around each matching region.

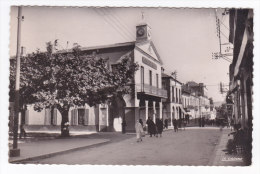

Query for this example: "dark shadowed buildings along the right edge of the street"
[226,9,254,163]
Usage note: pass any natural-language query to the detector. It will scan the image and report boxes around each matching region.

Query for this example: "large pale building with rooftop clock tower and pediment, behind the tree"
[14,23,168,131]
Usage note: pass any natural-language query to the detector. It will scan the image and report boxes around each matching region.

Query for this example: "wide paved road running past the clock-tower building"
[26,129,221,165]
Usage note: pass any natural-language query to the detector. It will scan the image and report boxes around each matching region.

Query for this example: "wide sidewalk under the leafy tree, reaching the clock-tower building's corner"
[9,131,134,163]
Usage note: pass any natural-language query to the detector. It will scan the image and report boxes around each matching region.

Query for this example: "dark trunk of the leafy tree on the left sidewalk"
[58,106,70,137]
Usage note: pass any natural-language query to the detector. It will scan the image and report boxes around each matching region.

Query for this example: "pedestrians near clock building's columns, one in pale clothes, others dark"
[135,117,164,142]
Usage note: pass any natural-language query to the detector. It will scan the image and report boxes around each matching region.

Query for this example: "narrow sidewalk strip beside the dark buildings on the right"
[208,128,245,166]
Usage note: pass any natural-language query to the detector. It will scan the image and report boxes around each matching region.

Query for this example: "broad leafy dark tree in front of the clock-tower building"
[10,42,138,136]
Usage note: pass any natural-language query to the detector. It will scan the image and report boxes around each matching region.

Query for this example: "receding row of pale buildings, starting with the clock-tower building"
[11,20,214,131]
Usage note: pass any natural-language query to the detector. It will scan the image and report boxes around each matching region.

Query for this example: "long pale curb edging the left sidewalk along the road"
[9,140,111,164]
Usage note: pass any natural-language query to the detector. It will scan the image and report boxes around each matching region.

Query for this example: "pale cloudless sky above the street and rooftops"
[10,7,230,101]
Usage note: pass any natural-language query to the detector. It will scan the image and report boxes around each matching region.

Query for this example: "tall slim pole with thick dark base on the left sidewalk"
[9,6,22,157]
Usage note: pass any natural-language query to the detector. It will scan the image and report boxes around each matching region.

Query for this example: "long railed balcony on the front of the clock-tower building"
[136,84,167,98]
